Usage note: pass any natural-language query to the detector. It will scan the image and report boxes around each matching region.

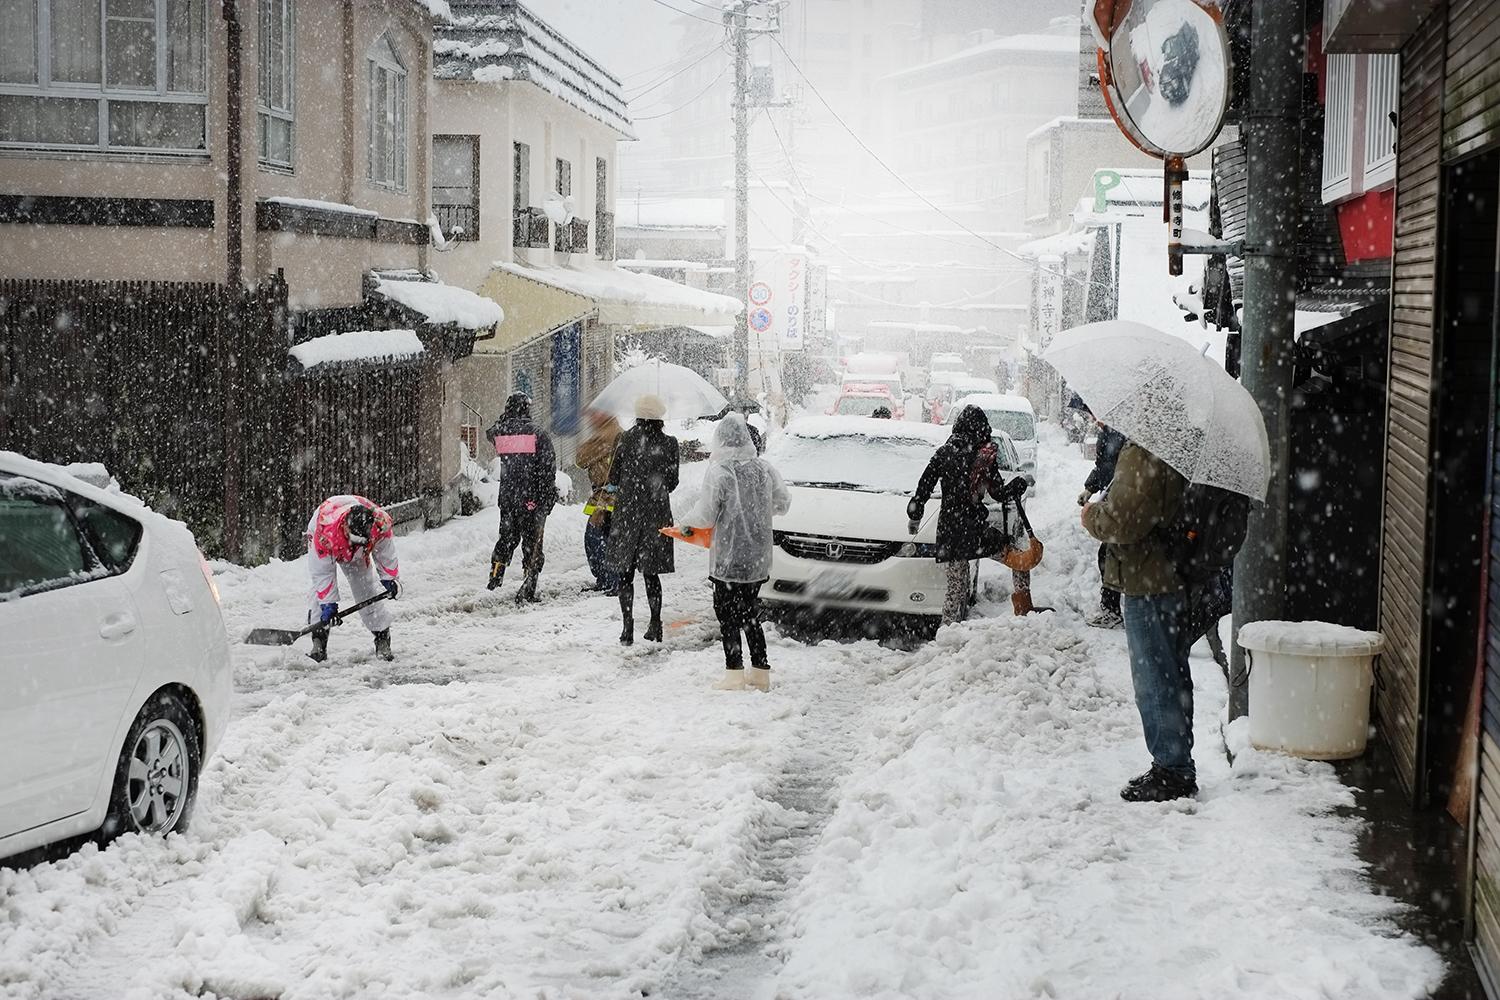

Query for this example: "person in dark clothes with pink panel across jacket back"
[485,393,558,604]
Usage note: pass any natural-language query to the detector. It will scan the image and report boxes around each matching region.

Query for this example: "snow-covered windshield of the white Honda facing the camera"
[765,432,938,493]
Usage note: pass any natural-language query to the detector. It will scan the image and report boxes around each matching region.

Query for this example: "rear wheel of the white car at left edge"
[99,691,203,843]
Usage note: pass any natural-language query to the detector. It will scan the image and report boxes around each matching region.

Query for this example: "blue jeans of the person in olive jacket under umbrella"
[1121,592,1197,780]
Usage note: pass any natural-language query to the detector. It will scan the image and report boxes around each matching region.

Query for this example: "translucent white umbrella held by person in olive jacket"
[1043,319,1271,501]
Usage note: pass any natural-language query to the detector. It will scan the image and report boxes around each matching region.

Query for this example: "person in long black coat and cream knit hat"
[606,396,678,646]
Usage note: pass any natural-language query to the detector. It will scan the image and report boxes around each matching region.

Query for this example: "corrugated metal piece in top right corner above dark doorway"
[1443,0,1500,159]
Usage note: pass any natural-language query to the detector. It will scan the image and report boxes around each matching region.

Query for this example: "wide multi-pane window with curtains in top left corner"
[0,0,209,154]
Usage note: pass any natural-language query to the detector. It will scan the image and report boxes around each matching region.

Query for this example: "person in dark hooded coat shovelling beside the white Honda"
[906,406,1047,624]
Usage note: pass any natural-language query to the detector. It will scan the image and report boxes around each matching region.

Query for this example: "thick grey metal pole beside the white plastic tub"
[1229,0,1307,720]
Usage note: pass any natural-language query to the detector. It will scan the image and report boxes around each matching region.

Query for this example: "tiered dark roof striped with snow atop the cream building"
[432,0,636,139]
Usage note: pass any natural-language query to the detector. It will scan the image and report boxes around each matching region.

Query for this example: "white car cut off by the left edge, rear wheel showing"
[0,451,231,858]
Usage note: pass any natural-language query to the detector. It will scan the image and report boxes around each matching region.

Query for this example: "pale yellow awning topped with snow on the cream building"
[476,261,740,352]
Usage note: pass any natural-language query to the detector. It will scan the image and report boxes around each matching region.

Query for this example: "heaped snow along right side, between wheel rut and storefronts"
[780,618,1442,1000]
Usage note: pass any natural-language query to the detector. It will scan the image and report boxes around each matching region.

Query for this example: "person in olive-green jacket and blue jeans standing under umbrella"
[1083,442,1199,802]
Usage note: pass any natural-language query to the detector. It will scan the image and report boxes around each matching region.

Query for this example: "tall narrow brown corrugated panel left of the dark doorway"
[1376,1,1445,792]
